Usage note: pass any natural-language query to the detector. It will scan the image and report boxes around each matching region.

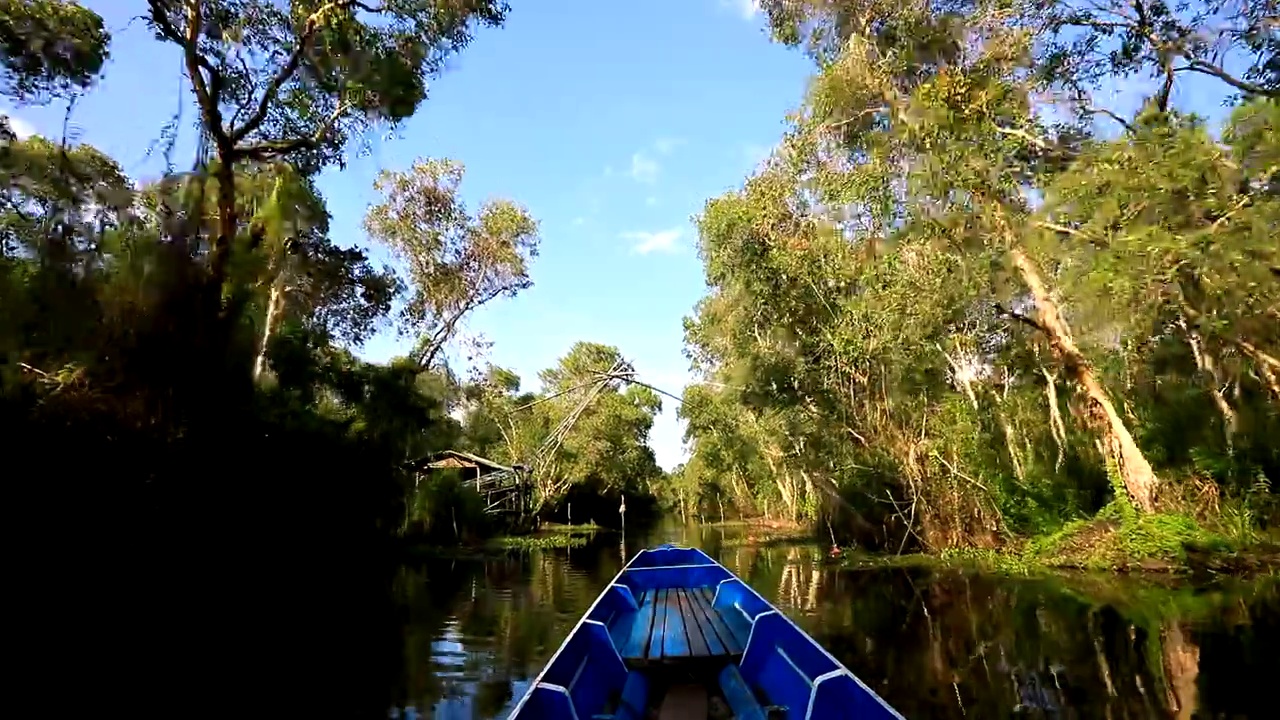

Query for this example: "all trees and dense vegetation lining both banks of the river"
[0,0,1280,716]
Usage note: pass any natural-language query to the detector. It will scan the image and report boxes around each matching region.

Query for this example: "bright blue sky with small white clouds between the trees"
[6,0,810,468]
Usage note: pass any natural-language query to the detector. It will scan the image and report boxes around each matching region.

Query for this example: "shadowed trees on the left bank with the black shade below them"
[0,0,659,714]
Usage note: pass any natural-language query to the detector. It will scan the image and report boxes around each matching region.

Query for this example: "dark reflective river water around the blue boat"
[385,527,1280,720]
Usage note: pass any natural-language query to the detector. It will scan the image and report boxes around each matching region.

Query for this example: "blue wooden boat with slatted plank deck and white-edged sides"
[508,544,901,720]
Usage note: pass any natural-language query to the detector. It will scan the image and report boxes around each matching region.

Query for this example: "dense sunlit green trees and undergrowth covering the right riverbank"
[673,0,1280,551]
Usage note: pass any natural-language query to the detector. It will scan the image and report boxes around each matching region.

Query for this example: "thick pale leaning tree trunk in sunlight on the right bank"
[1010,246,1158,512]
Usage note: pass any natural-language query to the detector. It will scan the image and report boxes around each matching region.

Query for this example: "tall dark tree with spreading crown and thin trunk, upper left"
[147,0,507,292]
